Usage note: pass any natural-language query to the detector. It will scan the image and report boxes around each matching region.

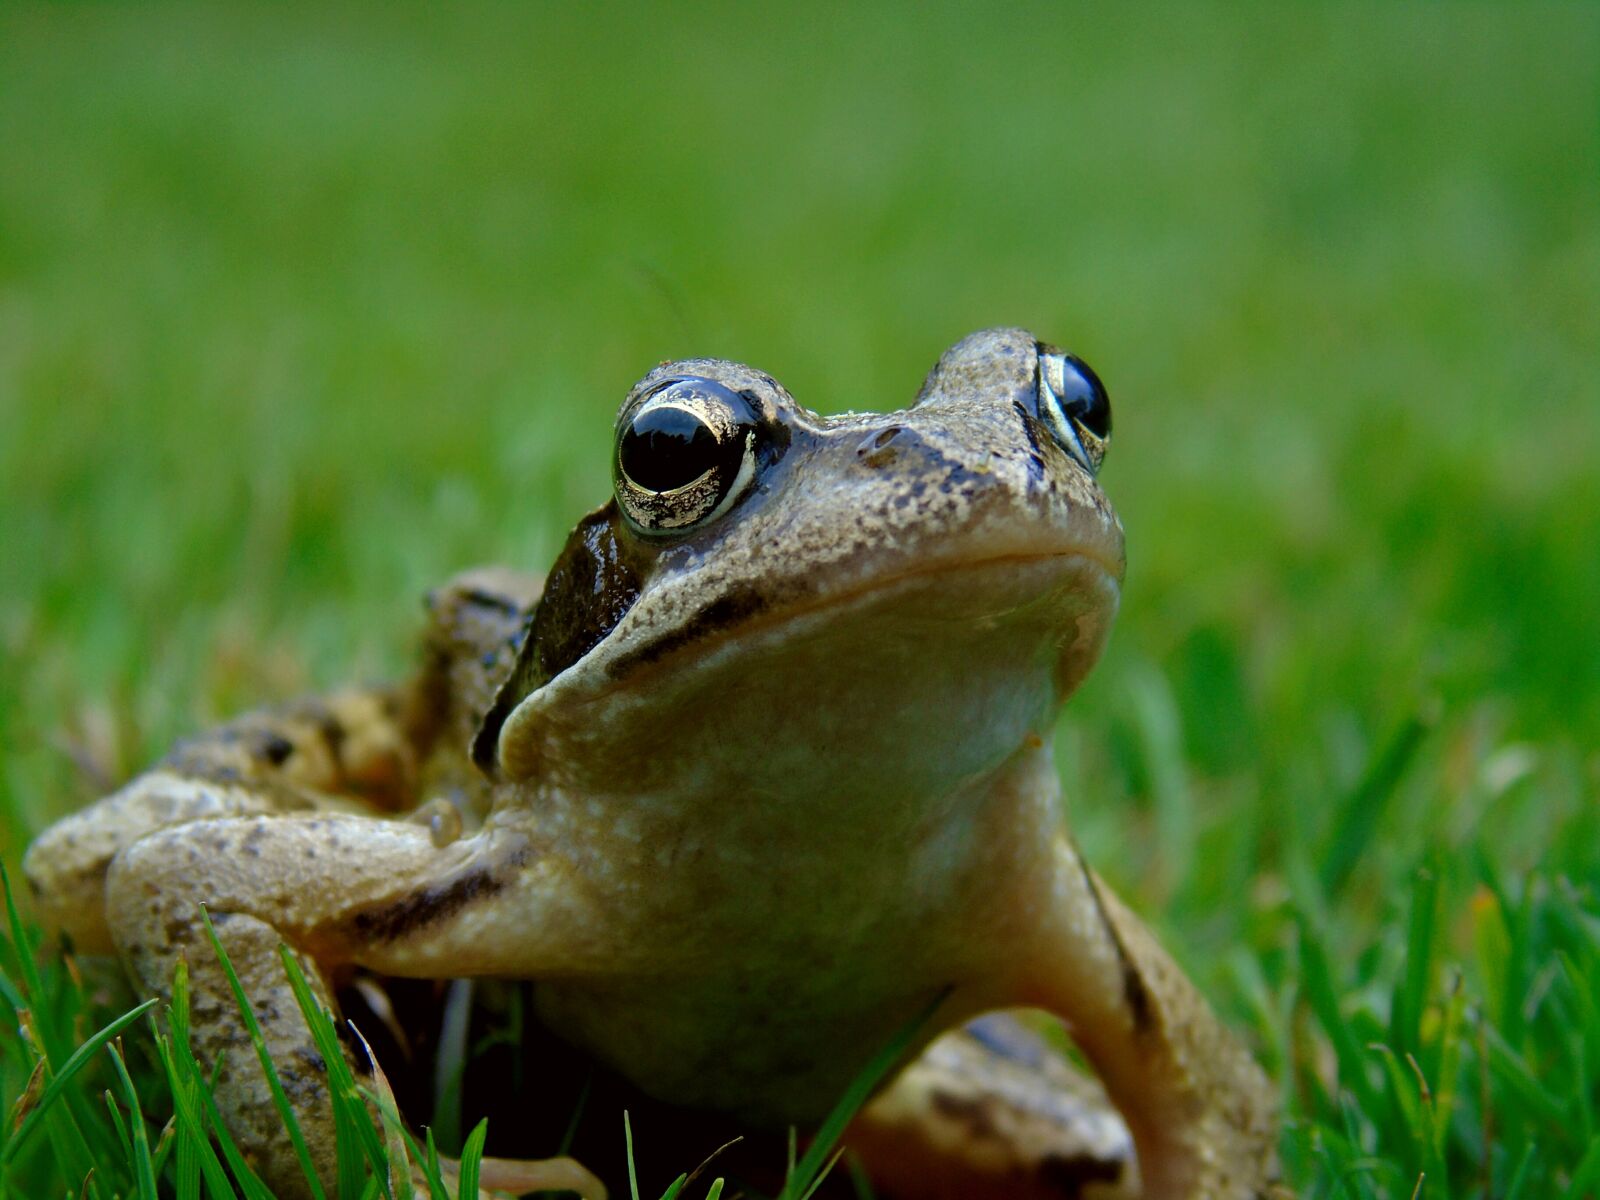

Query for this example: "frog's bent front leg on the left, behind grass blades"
[106,814,570,1197]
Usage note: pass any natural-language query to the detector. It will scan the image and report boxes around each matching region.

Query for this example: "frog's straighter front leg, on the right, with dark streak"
[1011,835,1278,1200]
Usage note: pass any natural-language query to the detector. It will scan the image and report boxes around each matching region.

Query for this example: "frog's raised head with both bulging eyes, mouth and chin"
[474,330,1123,809]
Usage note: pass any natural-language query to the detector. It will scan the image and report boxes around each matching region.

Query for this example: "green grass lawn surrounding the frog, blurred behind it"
[0,3,1600,1200]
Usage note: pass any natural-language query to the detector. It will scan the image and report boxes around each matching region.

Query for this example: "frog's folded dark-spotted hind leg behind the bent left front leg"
[22,688,418,954]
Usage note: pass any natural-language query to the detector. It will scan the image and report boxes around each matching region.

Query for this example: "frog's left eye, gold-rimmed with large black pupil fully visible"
[611,376,757,534]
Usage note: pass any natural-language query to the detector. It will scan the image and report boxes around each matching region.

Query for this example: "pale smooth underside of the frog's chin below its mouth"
[499,550,1120,794]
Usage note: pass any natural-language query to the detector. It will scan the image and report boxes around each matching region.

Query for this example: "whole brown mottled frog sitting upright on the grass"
[24,328,1278,1200]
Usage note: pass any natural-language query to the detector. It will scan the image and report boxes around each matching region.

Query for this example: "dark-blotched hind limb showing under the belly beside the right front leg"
[846,1013,1139,1200]
